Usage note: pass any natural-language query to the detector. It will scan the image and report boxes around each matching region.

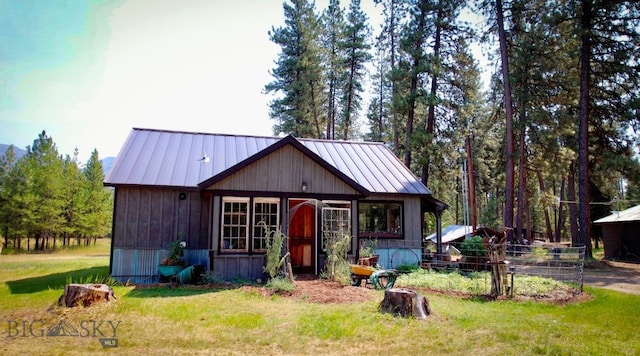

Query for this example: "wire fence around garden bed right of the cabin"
[423,242,585,292]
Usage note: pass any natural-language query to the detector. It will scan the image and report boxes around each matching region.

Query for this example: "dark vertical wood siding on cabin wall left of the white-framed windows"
[112,187,210,249]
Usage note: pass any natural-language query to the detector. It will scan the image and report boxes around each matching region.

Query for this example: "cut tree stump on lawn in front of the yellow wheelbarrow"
[380,288,431,319]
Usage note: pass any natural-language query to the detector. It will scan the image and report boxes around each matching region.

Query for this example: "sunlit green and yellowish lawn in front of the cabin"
[0,241,640,355]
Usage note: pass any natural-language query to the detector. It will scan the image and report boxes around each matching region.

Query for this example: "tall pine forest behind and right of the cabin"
[265,0,640,256]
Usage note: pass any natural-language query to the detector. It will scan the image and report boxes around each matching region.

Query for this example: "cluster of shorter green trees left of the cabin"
[0,131,113,251]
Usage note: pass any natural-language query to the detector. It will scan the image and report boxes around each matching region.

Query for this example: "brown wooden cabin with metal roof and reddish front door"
[104,128,447,283]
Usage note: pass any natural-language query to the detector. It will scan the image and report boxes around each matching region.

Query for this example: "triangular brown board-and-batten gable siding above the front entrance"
[208,145,359,196]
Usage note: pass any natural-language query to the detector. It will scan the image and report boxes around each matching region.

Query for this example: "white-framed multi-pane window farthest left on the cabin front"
[222,198,249,252]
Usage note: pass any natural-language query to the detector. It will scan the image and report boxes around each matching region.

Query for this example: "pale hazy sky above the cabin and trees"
[0,0,482,162]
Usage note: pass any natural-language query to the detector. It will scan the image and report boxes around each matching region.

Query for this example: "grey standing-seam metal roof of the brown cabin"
[104,128,431,195]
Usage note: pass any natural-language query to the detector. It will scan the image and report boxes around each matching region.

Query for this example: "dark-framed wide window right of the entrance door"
[358,202,404,238]
